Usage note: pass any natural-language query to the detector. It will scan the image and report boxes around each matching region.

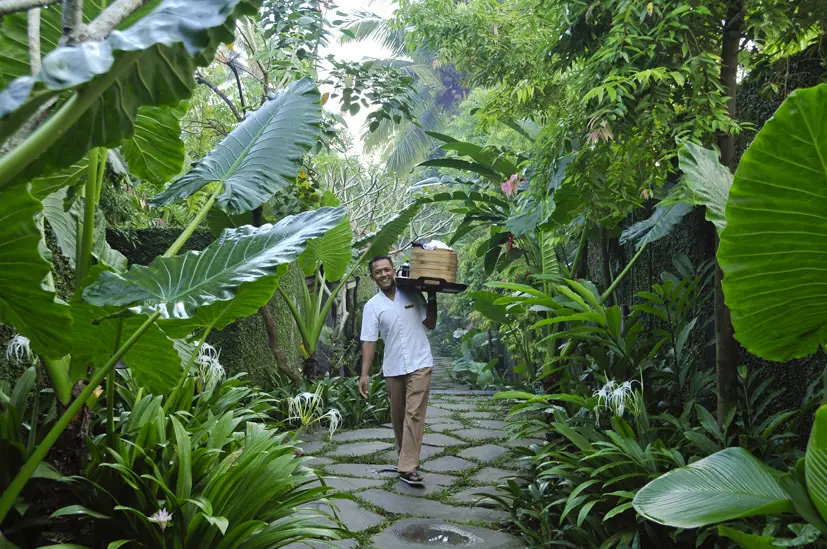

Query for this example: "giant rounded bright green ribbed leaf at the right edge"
[718,84,827,361]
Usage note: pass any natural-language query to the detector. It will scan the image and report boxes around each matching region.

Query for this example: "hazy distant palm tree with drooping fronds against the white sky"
[341,10,469,173]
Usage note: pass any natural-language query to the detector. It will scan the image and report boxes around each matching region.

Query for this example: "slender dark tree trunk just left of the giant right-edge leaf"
[713,0,744,424]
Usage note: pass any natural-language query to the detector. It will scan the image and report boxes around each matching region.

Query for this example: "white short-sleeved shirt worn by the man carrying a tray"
[361,288,434,377]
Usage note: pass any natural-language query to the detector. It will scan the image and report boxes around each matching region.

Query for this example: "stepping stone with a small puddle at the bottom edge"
[370,519,525,549]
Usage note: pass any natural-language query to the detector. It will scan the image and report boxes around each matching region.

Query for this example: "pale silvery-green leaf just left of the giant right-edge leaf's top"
[678,143,732,233]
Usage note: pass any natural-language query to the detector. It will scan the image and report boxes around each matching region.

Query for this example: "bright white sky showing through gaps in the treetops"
[321,0,395,153]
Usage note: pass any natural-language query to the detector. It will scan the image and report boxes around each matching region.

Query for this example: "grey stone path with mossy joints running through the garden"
[288,359,529,549]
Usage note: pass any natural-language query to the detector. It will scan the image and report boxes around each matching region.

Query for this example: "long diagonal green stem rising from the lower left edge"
[0,313,161,523]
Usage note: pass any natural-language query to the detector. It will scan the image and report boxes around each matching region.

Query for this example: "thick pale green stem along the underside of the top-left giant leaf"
[0,52,141,189]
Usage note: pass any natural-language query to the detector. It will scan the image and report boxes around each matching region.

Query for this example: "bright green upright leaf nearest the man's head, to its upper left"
[299,192,353,282]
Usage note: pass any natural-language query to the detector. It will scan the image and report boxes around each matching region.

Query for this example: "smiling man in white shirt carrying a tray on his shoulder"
[359,256,436,485]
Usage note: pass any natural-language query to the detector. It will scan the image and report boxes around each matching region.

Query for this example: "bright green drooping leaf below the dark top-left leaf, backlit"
[121,106,184,188]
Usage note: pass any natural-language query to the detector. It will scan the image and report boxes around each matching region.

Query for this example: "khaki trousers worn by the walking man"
[385,368,431,473]
